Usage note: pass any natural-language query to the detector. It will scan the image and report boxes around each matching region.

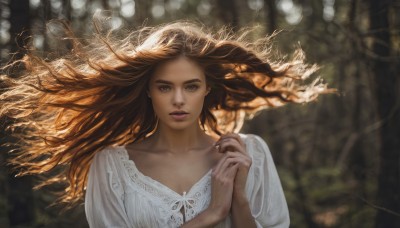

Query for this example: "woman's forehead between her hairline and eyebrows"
[151,56,205,83]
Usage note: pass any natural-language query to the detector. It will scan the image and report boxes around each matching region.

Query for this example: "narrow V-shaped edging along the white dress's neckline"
[121,145,212,198]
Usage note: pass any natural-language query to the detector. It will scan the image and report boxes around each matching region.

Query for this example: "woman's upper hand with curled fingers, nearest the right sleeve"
[216,133,252,197]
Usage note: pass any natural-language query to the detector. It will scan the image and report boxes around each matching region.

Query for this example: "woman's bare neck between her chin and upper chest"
[152,124,213,153]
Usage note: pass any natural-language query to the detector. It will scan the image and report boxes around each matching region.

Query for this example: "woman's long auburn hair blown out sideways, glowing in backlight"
[0,16,332,205]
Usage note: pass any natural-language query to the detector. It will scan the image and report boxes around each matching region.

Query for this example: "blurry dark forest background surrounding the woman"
[0,0,400,228]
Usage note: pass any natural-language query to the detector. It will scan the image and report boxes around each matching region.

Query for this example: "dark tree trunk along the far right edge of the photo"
[369,0,400,228]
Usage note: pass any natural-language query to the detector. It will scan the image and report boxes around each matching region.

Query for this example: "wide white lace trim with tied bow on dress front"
[116,146,211,227]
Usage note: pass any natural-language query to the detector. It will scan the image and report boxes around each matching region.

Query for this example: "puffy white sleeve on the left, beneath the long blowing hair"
[85,149,129,228]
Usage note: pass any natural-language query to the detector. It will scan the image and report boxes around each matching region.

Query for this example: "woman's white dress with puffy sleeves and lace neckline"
[85,134,289,228]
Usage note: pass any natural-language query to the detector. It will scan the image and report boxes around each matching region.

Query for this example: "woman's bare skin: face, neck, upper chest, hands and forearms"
[126,57,256,227]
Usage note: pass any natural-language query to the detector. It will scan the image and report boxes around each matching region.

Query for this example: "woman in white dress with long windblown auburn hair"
[0,17,331,227]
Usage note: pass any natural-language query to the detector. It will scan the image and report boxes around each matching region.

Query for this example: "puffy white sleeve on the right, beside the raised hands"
[246,135,290,228]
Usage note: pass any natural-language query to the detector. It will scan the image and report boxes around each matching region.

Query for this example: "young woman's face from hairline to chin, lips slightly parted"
[149,57,208,130]
